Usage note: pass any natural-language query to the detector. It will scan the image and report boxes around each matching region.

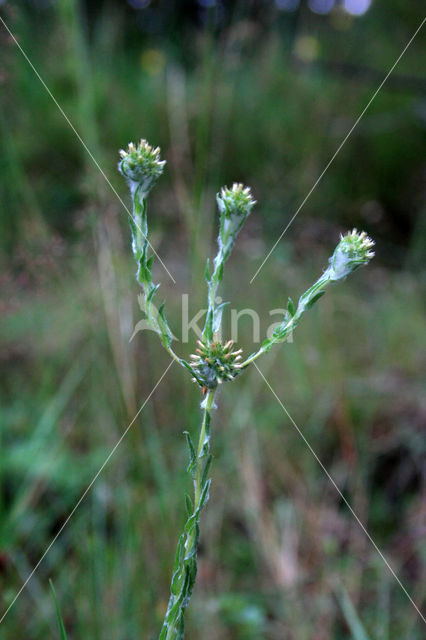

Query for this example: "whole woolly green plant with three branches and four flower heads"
[119,140,374,640]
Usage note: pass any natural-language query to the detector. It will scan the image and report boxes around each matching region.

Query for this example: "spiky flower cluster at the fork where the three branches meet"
[191,336,242,389]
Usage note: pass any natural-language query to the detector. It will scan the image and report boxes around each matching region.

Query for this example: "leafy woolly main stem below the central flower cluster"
[159,389,216,640]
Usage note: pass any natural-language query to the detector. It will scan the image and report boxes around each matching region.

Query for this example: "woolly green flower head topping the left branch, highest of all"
[118,140,166,194]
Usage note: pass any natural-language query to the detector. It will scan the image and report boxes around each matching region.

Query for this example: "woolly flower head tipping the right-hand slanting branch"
[327,229,374,280]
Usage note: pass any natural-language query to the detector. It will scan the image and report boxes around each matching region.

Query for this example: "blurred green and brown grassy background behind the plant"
[0,0,426,640]
